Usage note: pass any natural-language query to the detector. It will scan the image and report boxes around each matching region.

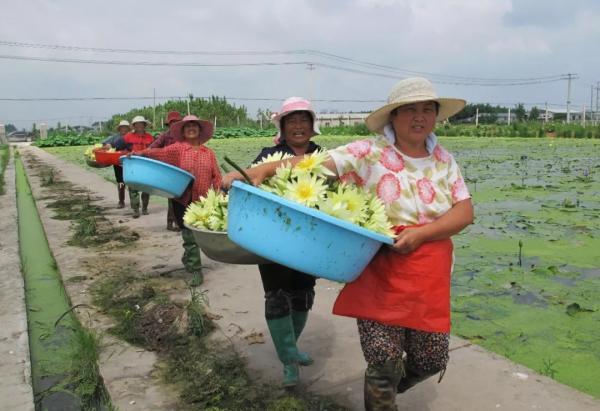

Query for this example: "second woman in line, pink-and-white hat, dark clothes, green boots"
[253,97,321,387]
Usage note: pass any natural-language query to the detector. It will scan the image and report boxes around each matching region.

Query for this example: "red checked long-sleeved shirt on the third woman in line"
[145,142,221,204]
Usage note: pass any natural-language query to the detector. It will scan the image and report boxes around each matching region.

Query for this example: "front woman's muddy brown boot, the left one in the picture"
[365,358,404,411]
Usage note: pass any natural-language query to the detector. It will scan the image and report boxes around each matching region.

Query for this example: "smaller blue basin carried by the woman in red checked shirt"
[121,156,194,198]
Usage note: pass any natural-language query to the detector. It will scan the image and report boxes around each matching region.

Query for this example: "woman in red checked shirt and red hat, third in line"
[135,115,221,286]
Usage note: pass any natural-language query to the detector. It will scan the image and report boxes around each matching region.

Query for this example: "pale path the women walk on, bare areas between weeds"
[15,143,600,411]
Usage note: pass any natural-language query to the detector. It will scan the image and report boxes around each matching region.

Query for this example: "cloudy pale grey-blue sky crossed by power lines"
[0,0,600,129]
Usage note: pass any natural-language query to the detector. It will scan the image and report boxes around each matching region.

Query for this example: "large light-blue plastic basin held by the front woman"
[227,181,393,283]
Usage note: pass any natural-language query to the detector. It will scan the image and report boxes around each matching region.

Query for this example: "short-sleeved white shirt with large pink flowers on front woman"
[328,136,470,225]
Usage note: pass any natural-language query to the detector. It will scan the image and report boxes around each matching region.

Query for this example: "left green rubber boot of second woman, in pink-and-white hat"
[267,315,300,387]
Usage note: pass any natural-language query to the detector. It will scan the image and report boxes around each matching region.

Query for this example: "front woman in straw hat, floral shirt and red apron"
[224,78,473,410]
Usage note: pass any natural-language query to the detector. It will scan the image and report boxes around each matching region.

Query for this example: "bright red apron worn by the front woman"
[333,229,453,333]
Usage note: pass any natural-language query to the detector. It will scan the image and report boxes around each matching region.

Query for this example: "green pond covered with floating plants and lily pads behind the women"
[47,136,600,397]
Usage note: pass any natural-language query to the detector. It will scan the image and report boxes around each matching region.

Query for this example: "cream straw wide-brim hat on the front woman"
[365,77,467,134]
